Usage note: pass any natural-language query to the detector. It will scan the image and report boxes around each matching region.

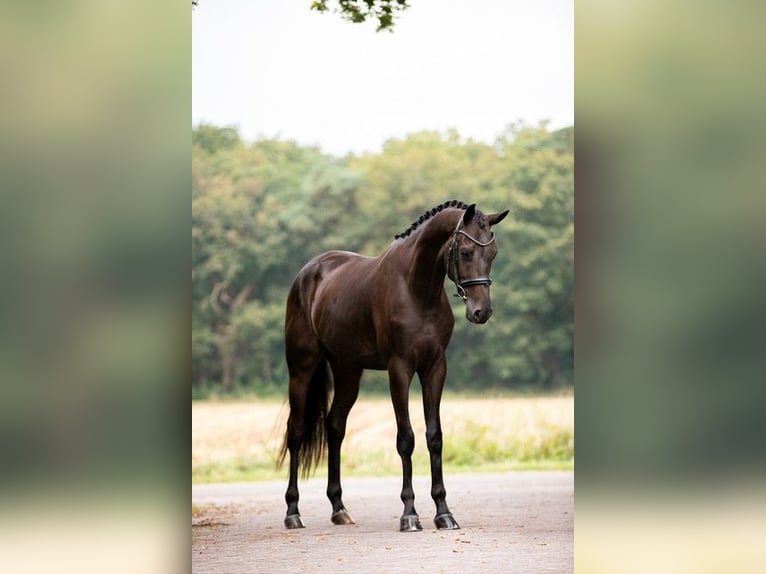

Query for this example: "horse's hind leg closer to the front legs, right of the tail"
[327,361,362,524]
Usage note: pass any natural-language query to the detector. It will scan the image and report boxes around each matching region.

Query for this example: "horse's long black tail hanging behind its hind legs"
[277,358,333,477]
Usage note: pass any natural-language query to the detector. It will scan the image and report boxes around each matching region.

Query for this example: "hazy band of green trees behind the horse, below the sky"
[191,124,574,396]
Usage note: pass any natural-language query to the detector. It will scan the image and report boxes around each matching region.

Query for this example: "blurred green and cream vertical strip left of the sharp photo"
[0,0,191,573]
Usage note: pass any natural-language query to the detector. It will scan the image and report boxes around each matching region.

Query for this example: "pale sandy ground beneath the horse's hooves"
[192,471,574,574]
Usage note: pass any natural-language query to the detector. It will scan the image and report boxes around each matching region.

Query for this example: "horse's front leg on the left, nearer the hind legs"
[388,359,423,532]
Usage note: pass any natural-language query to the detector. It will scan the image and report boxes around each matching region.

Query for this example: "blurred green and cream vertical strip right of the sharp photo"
[575,0,766,572]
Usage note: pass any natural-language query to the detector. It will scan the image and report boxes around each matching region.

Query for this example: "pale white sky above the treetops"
[192,0,574,155]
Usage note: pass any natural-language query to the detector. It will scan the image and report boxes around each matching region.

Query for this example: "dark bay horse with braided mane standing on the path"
[279,200,508,532]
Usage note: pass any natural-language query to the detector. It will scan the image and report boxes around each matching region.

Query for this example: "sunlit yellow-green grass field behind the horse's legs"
[192,391,574,482]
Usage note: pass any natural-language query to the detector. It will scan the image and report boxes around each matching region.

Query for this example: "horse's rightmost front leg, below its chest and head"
[418,355,460,530]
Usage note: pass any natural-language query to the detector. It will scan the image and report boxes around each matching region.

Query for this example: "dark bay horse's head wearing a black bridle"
[445,203,508,324]
